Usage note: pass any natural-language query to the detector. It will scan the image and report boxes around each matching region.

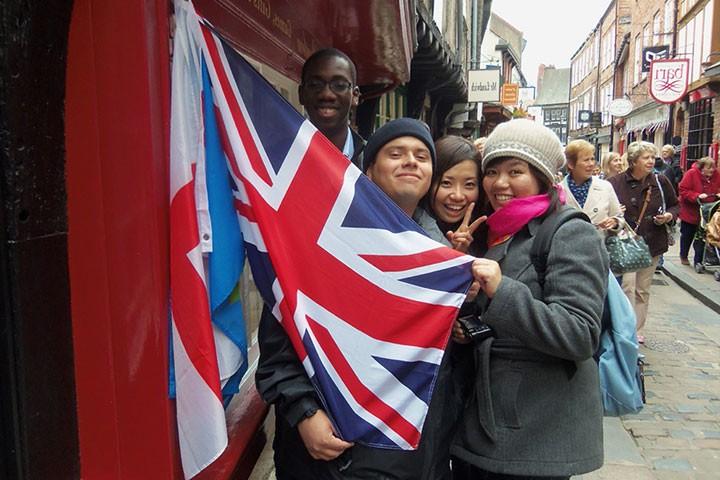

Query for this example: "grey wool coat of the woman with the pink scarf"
[451,219,608,476]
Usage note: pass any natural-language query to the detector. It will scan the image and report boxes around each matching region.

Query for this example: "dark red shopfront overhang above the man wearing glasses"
[195,0,416,91]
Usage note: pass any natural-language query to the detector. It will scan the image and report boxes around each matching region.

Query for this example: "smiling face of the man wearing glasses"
[299,56,360,137]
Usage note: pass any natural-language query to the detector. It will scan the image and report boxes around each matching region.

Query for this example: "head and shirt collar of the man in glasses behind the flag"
[298,48,365,166]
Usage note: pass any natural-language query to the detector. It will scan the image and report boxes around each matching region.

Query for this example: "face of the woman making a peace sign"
[432,159,480,223]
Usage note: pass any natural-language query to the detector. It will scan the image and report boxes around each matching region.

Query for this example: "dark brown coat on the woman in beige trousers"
[608,170,680,257]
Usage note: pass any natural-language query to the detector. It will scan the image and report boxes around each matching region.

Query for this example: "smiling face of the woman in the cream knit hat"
[482,158,541,210]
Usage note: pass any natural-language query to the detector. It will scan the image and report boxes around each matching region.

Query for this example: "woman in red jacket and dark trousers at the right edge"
[679,157,720,273]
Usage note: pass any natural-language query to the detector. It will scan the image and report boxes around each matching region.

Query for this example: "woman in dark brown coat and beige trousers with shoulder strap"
[610,142,680,343]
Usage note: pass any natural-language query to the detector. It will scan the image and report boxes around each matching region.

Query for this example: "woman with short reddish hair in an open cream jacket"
[562,140,622,233]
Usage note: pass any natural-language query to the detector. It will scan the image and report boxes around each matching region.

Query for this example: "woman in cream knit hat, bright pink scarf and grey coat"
[451,119,608,479]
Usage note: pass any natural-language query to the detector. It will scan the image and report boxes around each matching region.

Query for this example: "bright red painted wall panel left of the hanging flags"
[66,0,180,479]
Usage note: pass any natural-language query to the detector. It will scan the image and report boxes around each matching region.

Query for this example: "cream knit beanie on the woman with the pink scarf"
[482,118,565,184]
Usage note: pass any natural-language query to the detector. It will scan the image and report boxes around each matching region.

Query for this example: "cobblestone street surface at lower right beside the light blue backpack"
[582,267,720,480]
